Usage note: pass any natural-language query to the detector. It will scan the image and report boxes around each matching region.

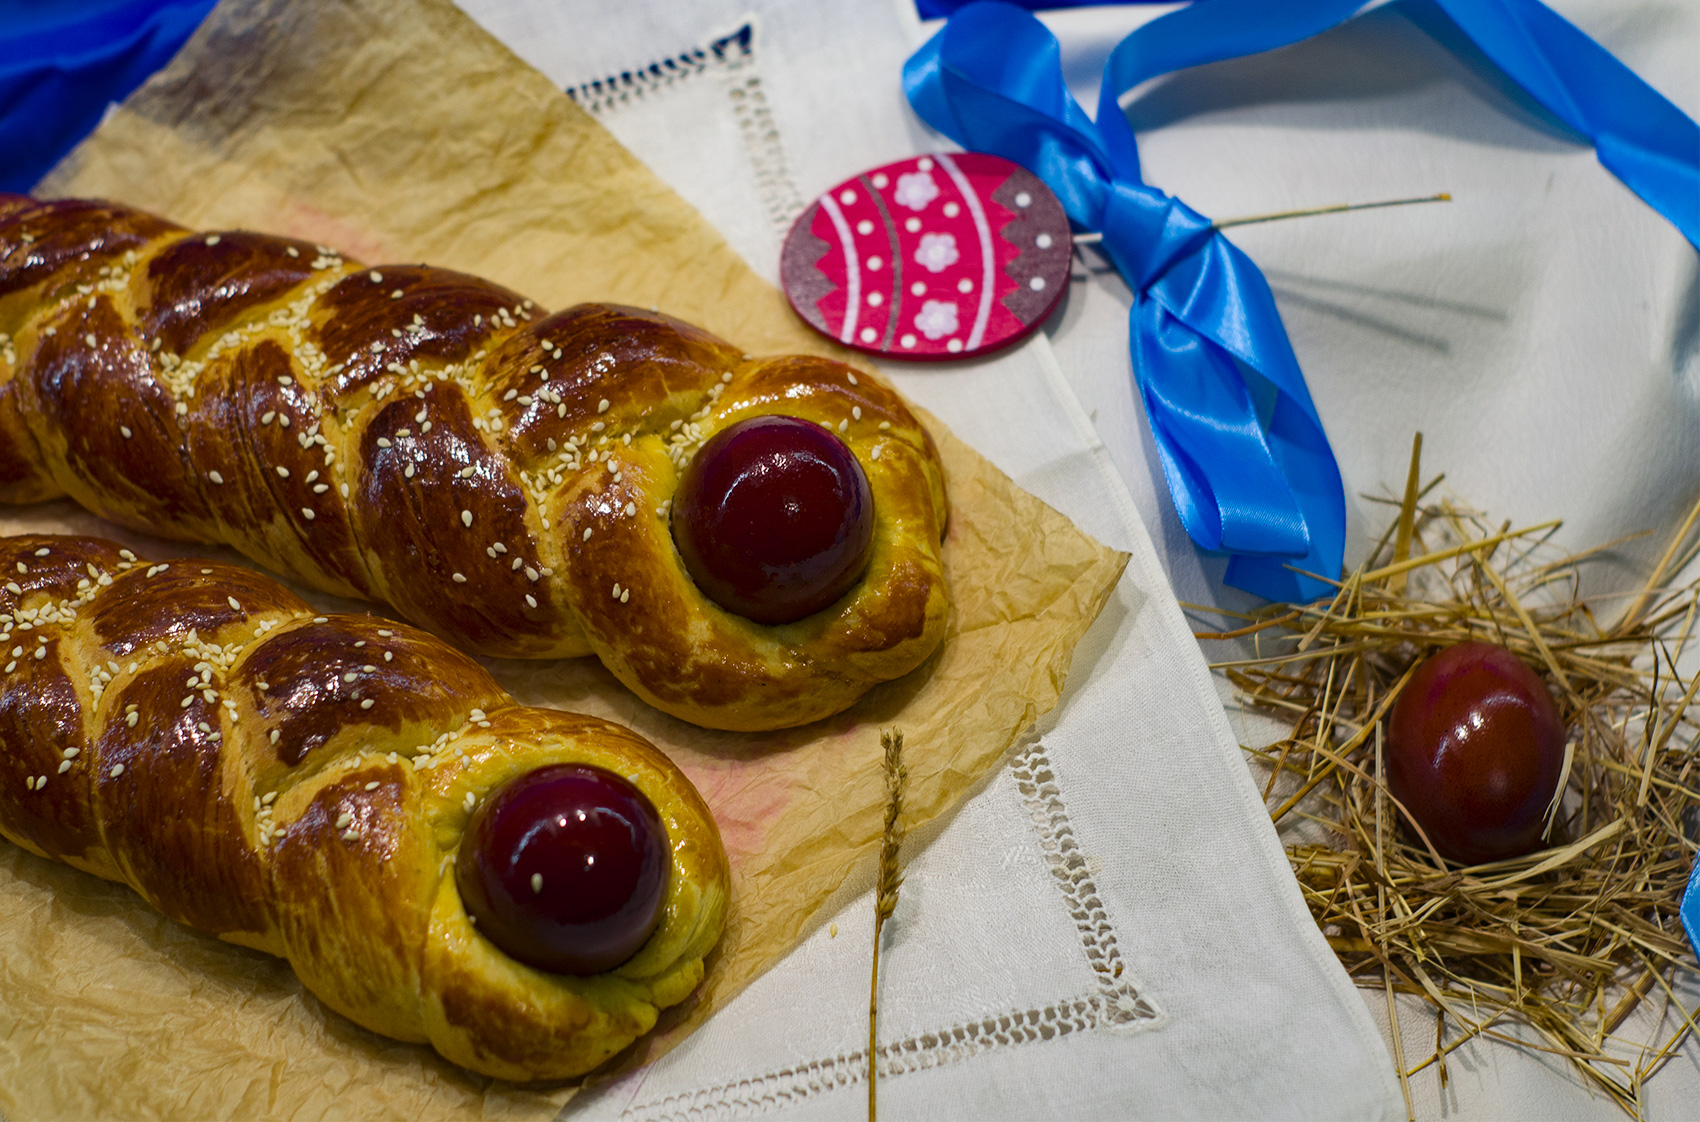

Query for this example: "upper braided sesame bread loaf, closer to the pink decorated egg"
[0,196,947,729]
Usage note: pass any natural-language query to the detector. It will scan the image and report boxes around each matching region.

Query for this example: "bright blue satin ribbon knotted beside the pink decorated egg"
[903,0,1700,600]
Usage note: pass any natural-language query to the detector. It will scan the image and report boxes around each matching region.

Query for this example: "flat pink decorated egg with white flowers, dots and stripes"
[780,151,1073,359]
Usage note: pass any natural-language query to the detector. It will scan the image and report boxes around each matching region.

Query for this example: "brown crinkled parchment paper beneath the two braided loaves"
[0,0,1127,1122]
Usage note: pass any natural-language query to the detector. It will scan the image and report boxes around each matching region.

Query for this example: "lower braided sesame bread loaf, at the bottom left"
[0,536,729,1080]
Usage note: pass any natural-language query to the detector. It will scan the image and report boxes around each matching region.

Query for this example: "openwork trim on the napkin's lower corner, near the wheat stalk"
[624,743,1163,1122]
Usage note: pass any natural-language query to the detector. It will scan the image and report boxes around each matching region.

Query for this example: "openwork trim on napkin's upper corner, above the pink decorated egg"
[566,19,802,236]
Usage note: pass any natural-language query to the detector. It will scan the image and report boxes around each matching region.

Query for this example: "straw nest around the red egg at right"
[1188,437,1700,1117]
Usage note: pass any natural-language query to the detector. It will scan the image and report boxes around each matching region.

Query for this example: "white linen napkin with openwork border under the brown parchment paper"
[448,0,1403,1119]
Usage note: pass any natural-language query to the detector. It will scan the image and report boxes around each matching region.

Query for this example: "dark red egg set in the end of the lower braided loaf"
[454,763,670,974]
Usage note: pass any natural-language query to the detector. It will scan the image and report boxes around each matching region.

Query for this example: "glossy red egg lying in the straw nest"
[1386,643,1564,865]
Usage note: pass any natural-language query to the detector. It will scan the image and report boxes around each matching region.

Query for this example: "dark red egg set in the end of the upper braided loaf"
[673,417,874,624]
